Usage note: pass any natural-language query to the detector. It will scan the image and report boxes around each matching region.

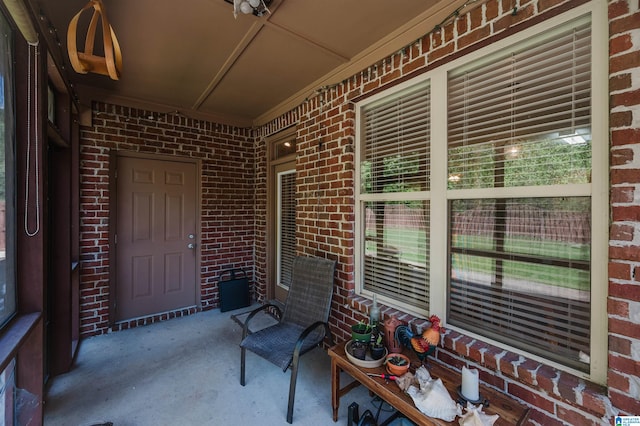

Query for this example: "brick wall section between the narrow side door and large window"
[296,92,355,337]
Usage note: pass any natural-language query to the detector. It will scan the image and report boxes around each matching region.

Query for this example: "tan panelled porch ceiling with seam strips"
[27,0,464,126]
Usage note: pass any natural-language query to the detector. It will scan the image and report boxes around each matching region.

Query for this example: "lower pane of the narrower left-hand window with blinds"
[363,201,429,310]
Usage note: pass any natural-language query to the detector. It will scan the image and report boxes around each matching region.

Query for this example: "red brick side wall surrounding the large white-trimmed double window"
[251,0,640,426]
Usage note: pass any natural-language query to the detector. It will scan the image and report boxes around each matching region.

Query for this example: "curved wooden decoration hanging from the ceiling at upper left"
[67,0,122,80]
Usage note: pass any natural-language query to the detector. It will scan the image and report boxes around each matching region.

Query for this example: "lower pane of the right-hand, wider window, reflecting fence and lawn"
[449,197,591,371]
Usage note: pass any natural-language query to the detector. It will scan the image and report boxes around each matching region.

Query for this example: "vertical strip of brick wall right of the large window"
[608,0,640,415]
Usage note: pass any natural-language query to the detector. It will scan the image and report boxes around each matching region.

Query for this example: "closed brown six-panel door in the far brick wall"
[115,156,199,321]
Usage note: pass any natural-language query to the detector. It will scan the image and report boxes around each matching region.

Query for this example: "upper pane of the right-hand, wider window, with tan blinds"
[448,18,591,189]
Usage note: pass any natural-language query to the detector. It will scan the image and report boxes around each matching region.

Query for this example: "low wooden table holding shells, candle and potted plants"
[329,342,529,426]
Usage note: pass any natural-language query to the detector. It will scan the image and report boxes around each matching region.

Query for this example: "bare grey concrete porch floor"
[44,308,386,426]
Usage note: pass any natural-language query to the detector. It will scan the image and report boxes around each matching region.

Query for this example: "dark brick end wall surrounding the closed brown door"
[80,104,256,336]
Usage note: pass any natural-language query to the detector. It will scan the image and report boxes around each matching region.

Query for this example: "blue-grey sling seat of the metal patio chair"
[240,322,324,371]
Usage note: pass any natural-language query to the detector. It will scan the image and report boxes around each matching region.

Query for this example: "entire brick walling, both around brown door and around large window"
[75,0,640,425]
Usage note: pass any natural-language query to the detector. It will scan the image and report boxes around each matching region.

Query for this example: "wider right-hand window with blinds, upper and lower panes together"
[447,15,591,371]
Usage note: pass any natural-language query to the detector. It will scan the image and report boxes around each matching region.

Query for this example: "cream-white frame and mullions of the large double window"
[354,0,609,384]
